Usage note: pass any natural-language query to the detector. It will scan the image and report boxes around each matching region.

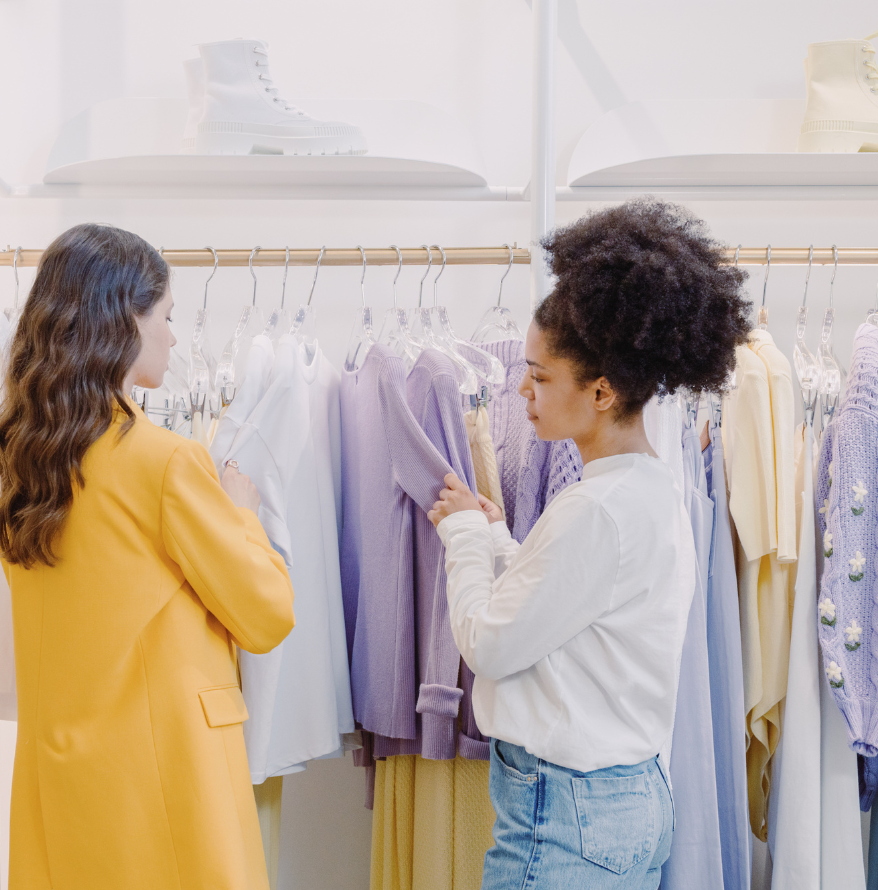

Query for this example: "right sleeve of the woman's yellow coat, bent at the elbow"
[162,442,295,653]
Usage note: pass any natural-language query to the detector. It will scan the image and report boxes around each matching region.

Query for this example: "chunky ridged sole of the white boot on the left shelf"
[195,121,366,156]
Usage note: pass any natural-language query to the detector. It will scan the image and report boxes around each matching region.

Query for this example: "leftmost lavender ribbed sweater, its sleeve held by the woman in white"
[341,345,458,740]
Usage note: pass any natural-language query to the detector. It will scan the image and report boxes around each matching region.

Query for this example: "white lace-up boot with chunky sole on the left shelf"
[195,40,366,155]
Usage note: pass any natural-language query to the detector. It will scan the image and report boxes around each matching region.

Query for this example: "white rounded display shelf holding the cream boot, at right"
[567,99,878,198]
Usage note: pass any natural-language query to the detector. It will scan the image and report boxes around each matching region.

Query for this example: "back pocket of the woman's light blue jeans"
[572,773,655,874]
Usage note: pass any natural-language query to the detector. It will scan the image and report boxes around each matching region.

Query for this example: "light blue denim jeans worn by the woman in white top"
[482,739,674,890]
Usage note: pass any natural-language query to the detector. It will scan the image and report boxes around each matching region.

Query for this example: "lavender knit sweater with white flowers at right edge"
[816,324,878,757]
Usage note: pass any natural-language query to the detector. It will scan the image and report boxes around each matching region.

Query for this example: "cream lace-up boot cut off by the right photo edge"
[799,34,878,152]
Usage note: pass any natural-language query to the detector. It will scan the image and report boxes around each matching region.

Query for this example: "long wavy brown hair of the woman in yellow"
[0,224,169,568]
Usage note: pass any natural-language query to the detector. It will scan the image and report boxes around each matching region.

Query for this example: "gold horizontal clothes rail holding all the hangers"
[0,244,878,268]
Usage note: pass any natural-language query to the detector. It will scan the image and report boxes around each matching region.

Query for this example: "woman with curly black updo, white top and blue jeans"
[430,200,750,890]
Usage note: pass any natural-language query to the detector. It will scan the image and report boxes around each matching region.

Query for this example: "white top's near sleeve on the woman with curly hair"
[439,497,620,680]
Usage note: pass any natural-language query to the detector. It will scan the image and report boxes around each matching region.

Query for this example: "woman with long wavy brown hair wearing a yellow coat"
[0,225,293,890]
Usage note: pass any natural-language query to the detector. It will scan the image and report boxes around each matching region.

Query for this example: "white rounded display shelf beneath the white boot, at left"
[31,99,492,200]
